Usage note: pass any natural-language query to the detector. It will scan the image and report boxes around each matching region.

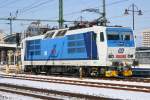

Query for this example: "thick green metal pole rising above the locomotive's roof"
[59,0,64,28]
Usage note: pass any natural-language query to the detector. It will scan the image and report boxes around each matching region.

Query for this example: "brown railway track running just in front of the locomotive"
[0,75,150,93]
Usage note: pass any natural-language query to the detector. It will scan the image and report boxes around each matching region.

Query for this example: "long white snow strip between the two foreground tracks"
[0,78,150,100]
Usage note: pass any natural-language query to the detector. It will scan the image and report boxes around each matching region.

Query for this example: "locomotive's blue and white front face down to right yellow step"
[106,27,135,76]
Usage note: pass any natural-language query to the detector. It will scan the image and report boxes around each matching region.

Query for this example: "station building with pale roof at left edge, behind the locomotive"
[0,33,21,65]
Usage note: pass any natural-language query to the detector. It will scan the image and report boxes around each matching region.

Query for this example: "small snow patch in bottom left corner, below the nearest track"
[0,91,41,100]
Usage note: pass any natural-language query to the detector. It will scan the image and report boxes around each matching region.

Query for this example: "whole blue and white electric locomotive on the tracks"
[21,26,135,77]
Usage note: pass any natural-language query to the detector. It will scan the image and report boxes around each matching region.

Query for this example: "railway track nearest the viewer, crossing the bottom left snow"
[0,83,113,100]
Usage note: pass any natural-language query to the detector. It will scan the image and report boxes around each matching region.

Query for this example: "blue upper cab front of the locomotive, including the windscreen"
[106,28,134,47]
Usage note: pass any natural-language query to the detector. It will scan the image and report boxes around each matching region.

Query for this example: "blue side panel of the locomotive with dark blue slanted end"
[25,32,97,61]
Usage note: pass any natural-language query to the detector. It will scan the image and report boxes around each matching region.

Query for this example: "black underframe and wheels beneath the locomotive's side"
[24,65,106,77]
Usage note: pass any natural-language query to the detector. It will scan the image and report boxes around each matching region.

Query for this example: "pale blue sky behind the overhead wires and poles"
[0,0,150,45]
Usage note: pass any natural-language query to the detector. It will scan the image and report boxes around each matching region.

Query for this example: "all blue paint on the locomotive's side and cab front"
[25,28,135,61]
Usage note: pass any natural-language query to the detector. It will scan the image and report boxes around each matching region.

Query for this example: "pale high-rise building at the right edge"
[142,29,150,47]
